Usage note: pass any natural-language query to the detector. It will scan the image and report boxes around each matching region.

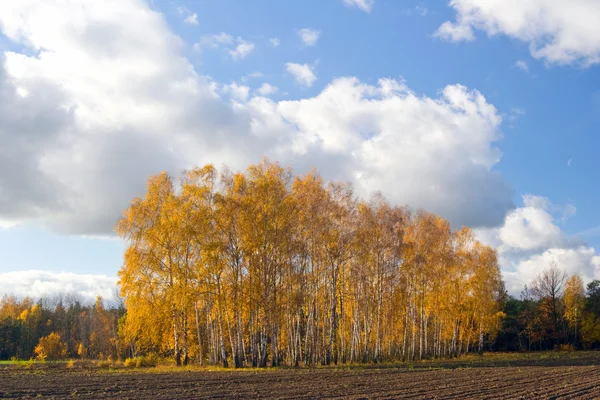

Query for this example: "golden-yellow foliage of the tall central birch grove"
[116,159,502,361]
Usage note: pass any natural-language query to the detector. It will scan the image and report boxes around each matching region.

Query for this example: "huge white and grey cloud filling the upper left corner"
[0,0,252,234]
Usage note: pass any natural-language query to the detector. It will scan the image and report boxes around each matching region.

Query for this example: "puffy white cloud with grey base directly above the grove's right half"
[244,78,512,226]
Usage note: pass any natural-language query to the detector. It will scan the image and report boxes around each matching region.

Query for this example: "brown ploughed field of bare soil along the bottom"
[0,353,600,399]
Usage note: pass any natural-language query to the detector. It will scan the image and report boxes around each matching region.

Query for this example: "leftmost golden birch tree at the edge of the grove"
[116,173,190,365]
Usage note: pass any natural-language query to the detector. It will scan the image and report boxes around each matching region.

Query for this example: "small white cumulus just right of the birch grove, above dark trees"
[475,195,600,295]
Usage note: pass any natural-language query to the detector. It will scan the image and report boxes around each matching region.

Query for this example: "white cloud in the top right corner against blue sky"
[436,0,600,66]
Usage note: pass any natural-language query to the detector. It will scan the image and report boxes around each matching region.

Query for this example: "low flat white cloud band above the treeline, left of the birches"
[0,270,117,303]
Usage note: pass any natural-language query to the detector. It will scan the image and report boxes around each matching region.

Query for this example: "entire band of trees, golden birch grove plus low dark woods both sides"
[0,160,600,367]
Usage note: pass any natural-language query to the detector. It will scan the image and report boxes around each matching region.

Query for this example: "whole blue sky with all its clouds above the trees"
[0,0,600,299]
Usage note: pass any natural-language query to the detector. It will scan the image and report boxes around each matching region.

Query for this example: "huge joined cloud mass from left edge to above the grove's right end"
[0,0,513,241]
